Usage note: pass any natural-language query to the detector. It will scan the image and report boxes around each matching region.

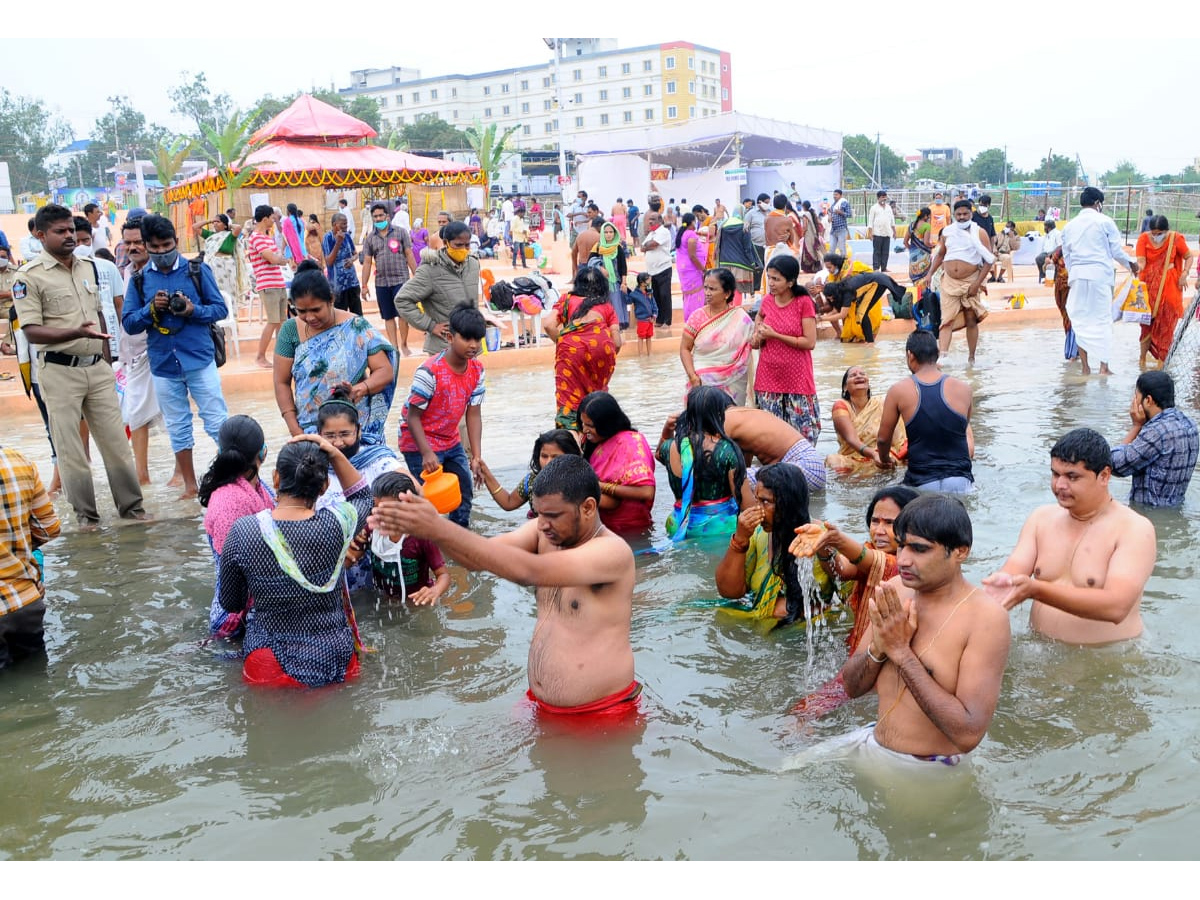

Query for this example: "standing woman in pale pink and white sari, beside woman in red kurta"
[679,269,754,406]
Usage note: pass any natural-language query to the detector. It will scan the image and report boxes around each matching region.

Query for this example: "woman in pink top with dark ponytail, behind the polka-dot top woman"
[199,415,275,638]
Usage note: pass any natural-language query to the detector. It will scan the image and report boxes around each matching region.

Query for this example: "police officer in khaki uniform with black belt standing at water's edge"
[12,203,146,528]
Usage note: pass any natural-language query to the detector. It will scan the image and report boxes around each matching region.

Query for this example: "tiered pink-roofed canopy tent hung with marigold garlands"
[164,94,484,240]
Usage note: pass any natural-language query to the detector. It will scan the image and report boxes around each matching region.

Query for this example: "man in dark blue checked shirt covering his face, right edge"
[1112,372,1200,506]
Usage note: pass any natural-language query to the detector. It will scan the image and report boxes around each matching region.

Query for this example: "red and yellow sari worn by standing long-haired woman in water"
[554,294,617,431]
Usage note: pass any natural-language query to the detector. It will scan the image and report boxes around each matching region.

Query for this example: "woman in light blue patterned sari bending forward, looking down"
[275,260,396,444]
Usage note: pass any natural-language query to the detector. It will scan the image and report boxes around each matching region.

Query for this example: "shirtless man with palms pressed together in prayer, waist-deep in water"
[841,494,1010,766]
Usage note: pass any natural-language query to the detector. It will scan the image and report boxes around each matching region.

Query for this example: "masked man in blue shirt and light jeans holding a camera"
[121,216,228,499]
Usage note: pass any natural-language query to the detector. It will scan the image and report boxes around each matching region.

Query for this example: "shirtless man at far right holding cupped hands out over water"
[983,428,1157,644]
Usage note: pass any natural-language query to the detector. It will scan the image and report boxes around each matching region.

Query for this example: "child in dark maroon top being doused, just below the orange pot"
[354,472,450,606]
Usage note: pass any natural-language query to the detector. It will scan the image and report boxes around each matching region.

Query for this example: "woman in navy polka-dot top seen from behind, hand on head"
[220,434,372,688]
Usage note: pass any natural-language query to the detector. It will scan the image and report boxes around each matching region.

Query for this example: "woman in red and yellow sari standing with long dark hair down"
[546,265,620,431]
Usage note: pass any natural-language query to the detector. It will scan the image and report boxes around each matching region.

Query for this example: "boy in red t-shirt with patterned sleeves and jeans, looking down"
[400,306,487,528]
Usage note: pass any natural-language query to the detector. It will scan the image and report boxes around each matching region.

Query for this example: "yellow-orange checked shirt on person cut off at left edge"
[0,446,59,614]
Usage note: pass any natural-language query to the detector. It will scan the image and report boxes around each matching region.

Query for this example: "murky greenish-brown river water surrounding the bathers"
[0,326,1200,859]
